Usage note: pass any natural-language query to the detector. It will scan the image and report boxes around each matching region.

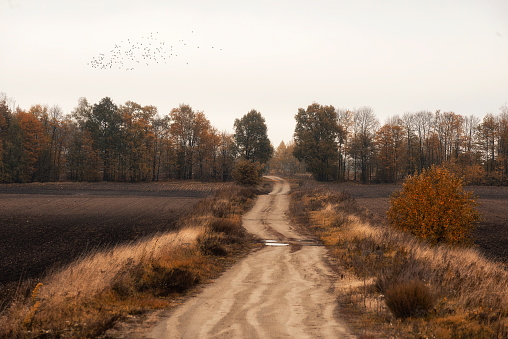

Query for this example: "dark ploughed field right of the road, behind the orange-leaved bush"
[308,182,508,264]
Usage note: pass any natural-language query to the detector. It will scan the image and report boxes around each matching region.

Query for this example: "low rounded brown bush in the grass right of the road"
[385,280,436,318]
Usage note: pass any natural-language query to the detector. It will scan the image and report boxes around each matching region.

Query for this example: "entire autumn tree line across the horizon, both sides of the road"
[0,94,508,185]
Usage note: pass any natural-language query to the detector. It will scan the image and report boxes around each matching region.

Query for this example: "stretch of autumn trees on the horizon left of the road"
[0,94,273,183]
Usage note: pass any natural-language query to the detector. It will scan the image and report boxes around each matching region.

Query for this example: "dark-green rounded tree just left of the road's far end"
[234,109,273,165]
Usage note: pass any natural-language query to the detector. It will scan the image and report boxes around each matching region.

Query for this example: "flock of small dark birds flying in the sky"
[87,31,222,71]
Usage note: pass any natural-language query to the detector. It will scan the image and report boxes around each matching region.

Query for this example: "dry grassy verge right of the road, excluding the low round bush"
[291,190,508,338]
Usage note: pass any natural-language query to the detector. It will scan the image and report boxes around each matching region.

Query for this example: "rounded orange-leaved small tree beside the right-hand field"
[388,166,479,245]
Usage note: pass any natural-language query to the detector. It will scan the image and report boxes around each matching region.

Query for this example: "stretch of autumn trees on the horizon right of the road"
[290,103,508,185]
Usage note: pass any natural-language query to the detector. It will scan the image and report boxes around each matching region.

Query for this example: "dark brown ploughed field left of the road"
[0,182,229,286]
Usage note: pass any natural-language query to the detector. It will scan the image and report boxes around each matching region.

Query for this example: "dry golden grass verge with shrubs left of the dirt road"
[0,186,270,338]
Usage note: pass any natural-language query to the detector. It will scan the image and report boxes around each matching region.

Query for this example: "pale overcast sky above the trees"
[0,0,508,146]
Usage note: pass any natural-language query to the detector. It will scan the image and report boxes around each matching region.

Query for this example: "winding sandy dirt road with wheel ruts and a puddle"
[148,177,353,338]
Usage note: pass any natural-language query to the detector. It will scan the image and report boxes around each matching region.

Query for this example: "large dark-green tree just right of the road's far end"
[293,103,343,181]
